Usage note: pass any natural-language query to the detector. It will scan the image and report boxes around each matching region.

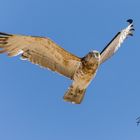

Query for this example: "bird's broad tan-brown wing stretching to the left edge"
[0,33,81,79]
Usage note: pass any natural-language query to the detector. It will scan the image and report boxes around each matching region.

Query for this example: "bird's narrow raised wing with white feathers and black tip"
[100,19,134,64]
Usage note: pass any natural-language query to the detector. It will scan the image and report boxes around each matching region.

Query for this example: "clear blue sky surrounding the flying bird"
[0,0,140,140]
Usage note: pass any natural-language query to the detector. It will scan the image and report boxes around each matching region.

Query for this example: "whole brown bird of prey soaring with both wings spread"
[0,19,134,104]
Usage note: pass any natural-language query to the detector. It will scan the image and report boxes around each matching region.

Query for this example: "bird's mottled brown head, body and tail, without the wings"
[64,52,100,103]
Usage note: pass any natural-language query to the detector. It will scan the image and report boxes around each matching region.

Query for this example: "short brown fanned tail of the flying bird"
[63,86,86,104]
